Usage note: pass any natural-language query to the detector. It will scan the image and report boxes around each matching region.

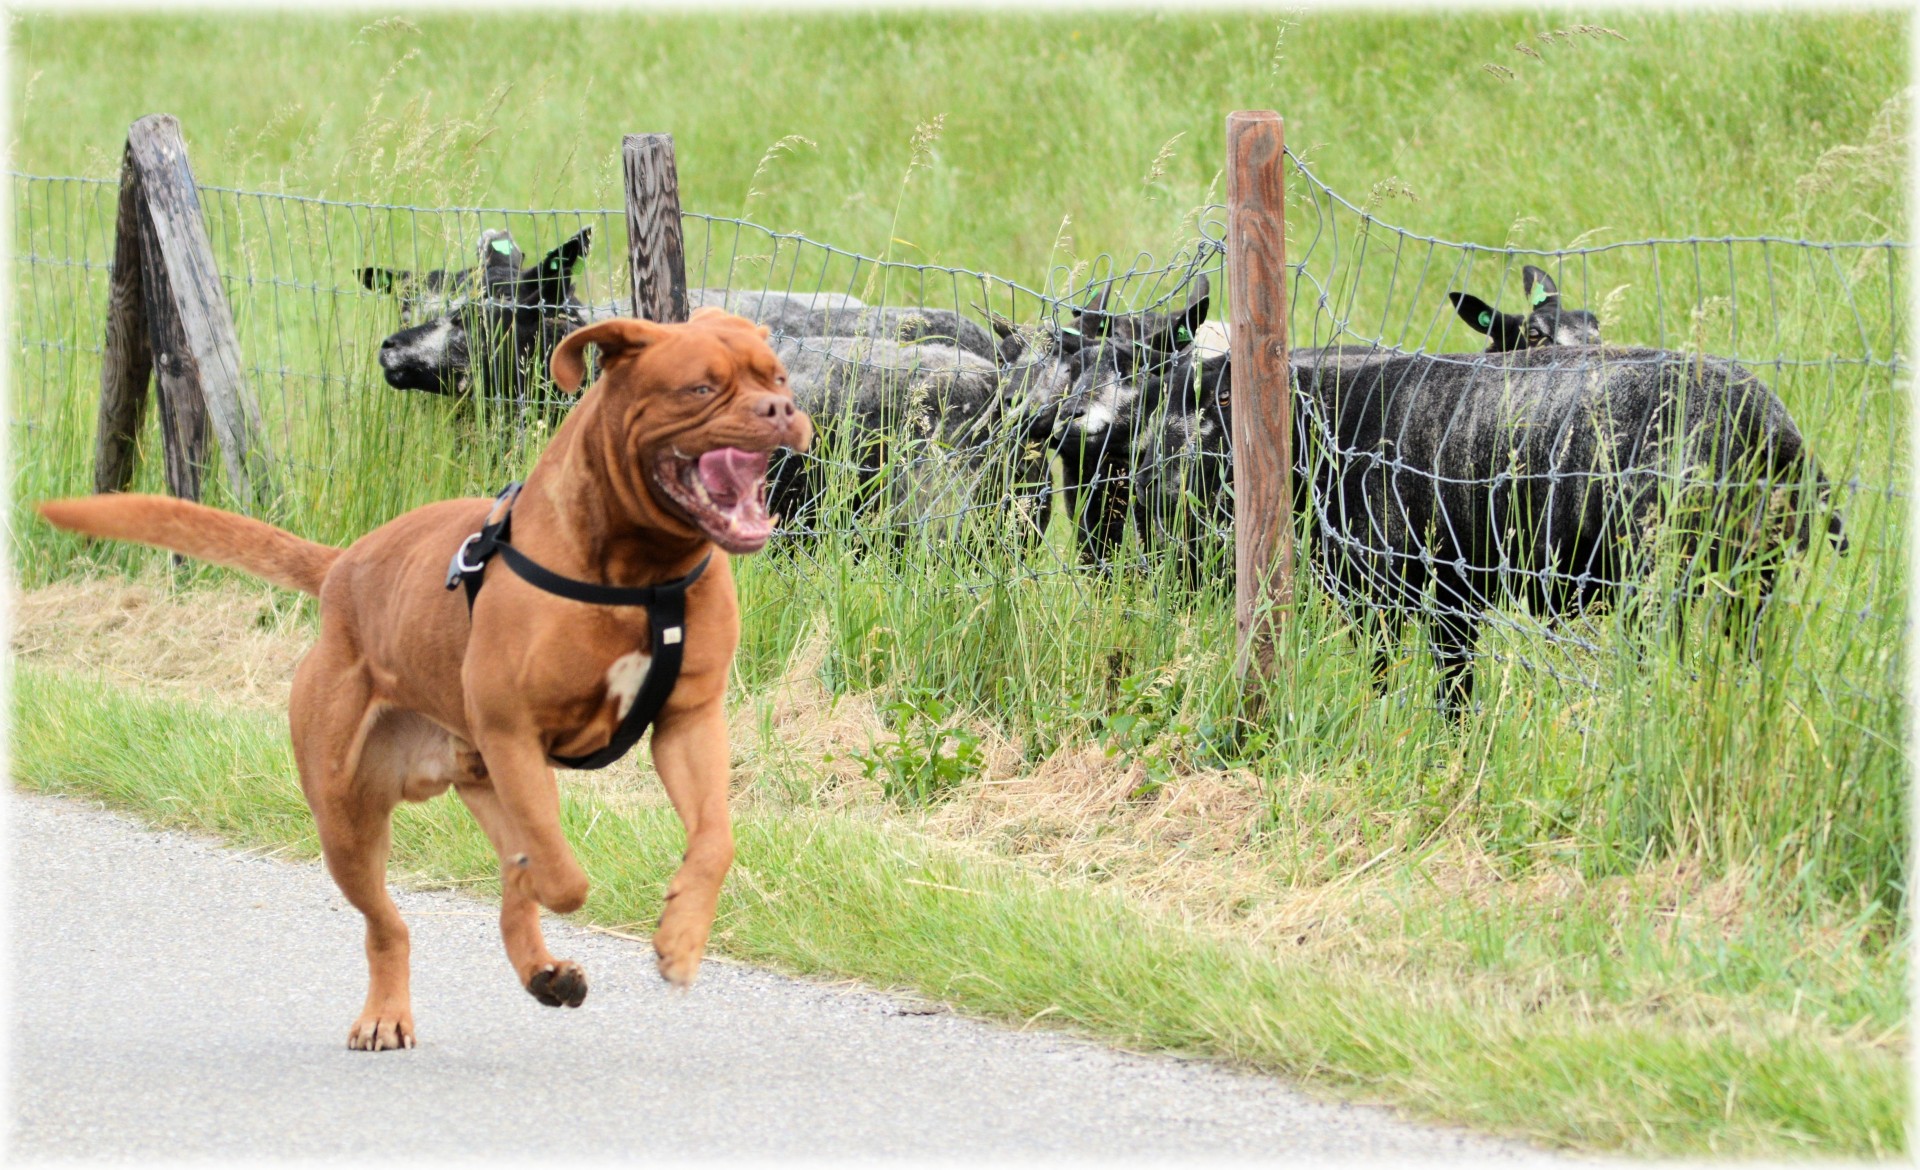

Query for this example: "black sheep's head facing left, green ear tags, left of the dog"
[359,227,593,394]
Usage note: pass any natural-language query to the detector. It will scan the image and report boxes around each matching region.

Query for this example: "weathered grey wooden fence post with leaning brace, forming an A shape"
[94,113,275,509]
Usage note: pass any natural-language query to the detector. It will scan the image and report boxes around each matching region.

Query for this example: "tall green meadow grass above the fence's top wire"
[12,10,1907,253]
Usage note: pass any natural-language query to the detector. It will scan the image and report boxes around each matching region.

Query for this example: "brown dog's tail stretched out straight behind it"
[40,492,344,596]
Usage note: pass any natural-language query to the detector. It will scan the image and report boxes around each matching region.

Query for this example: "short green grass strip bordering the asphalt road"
[13,667,1907,1155]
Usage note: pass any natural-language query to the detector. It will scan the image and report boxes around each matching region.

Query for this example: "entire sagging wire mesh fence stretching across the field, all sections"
[12,146,1907,701]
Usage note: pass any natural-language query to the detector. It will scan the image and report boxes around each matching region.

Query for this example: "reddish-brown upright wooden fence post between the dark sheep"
[1227,110,1294,678]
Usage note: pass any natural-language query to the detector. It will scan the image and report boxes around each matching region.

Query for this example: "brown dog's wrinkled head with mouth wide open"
[553,309,814,553]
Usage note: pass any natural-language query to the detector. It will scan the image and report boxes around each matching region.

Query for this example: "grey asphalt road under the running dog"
[8,792,1546,1162]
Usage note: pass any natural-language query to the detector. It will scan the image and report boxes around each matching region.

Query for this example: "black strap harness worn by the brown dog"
[447,484,712,770]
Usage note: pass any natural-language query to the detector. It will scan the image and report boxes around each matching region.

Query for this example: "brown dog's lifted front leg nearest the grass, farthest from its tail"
[653,699,733,987]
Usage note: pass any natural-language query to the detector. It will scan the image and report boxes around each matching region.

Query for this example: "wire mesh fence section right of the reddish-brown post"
[1288,149,1908,701]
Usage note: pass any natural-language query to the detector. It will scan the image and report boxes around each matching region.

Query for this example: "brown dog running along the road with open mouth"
[40,309,812,1051]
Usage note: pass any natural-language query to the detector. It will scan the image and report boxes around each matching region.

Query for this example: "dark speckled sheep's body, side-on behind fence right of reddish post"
[1294,346,1845,709]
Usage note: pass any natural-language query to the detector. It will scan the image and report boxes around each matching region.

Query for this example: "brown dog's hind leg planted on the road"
[292,628,415,1051]
